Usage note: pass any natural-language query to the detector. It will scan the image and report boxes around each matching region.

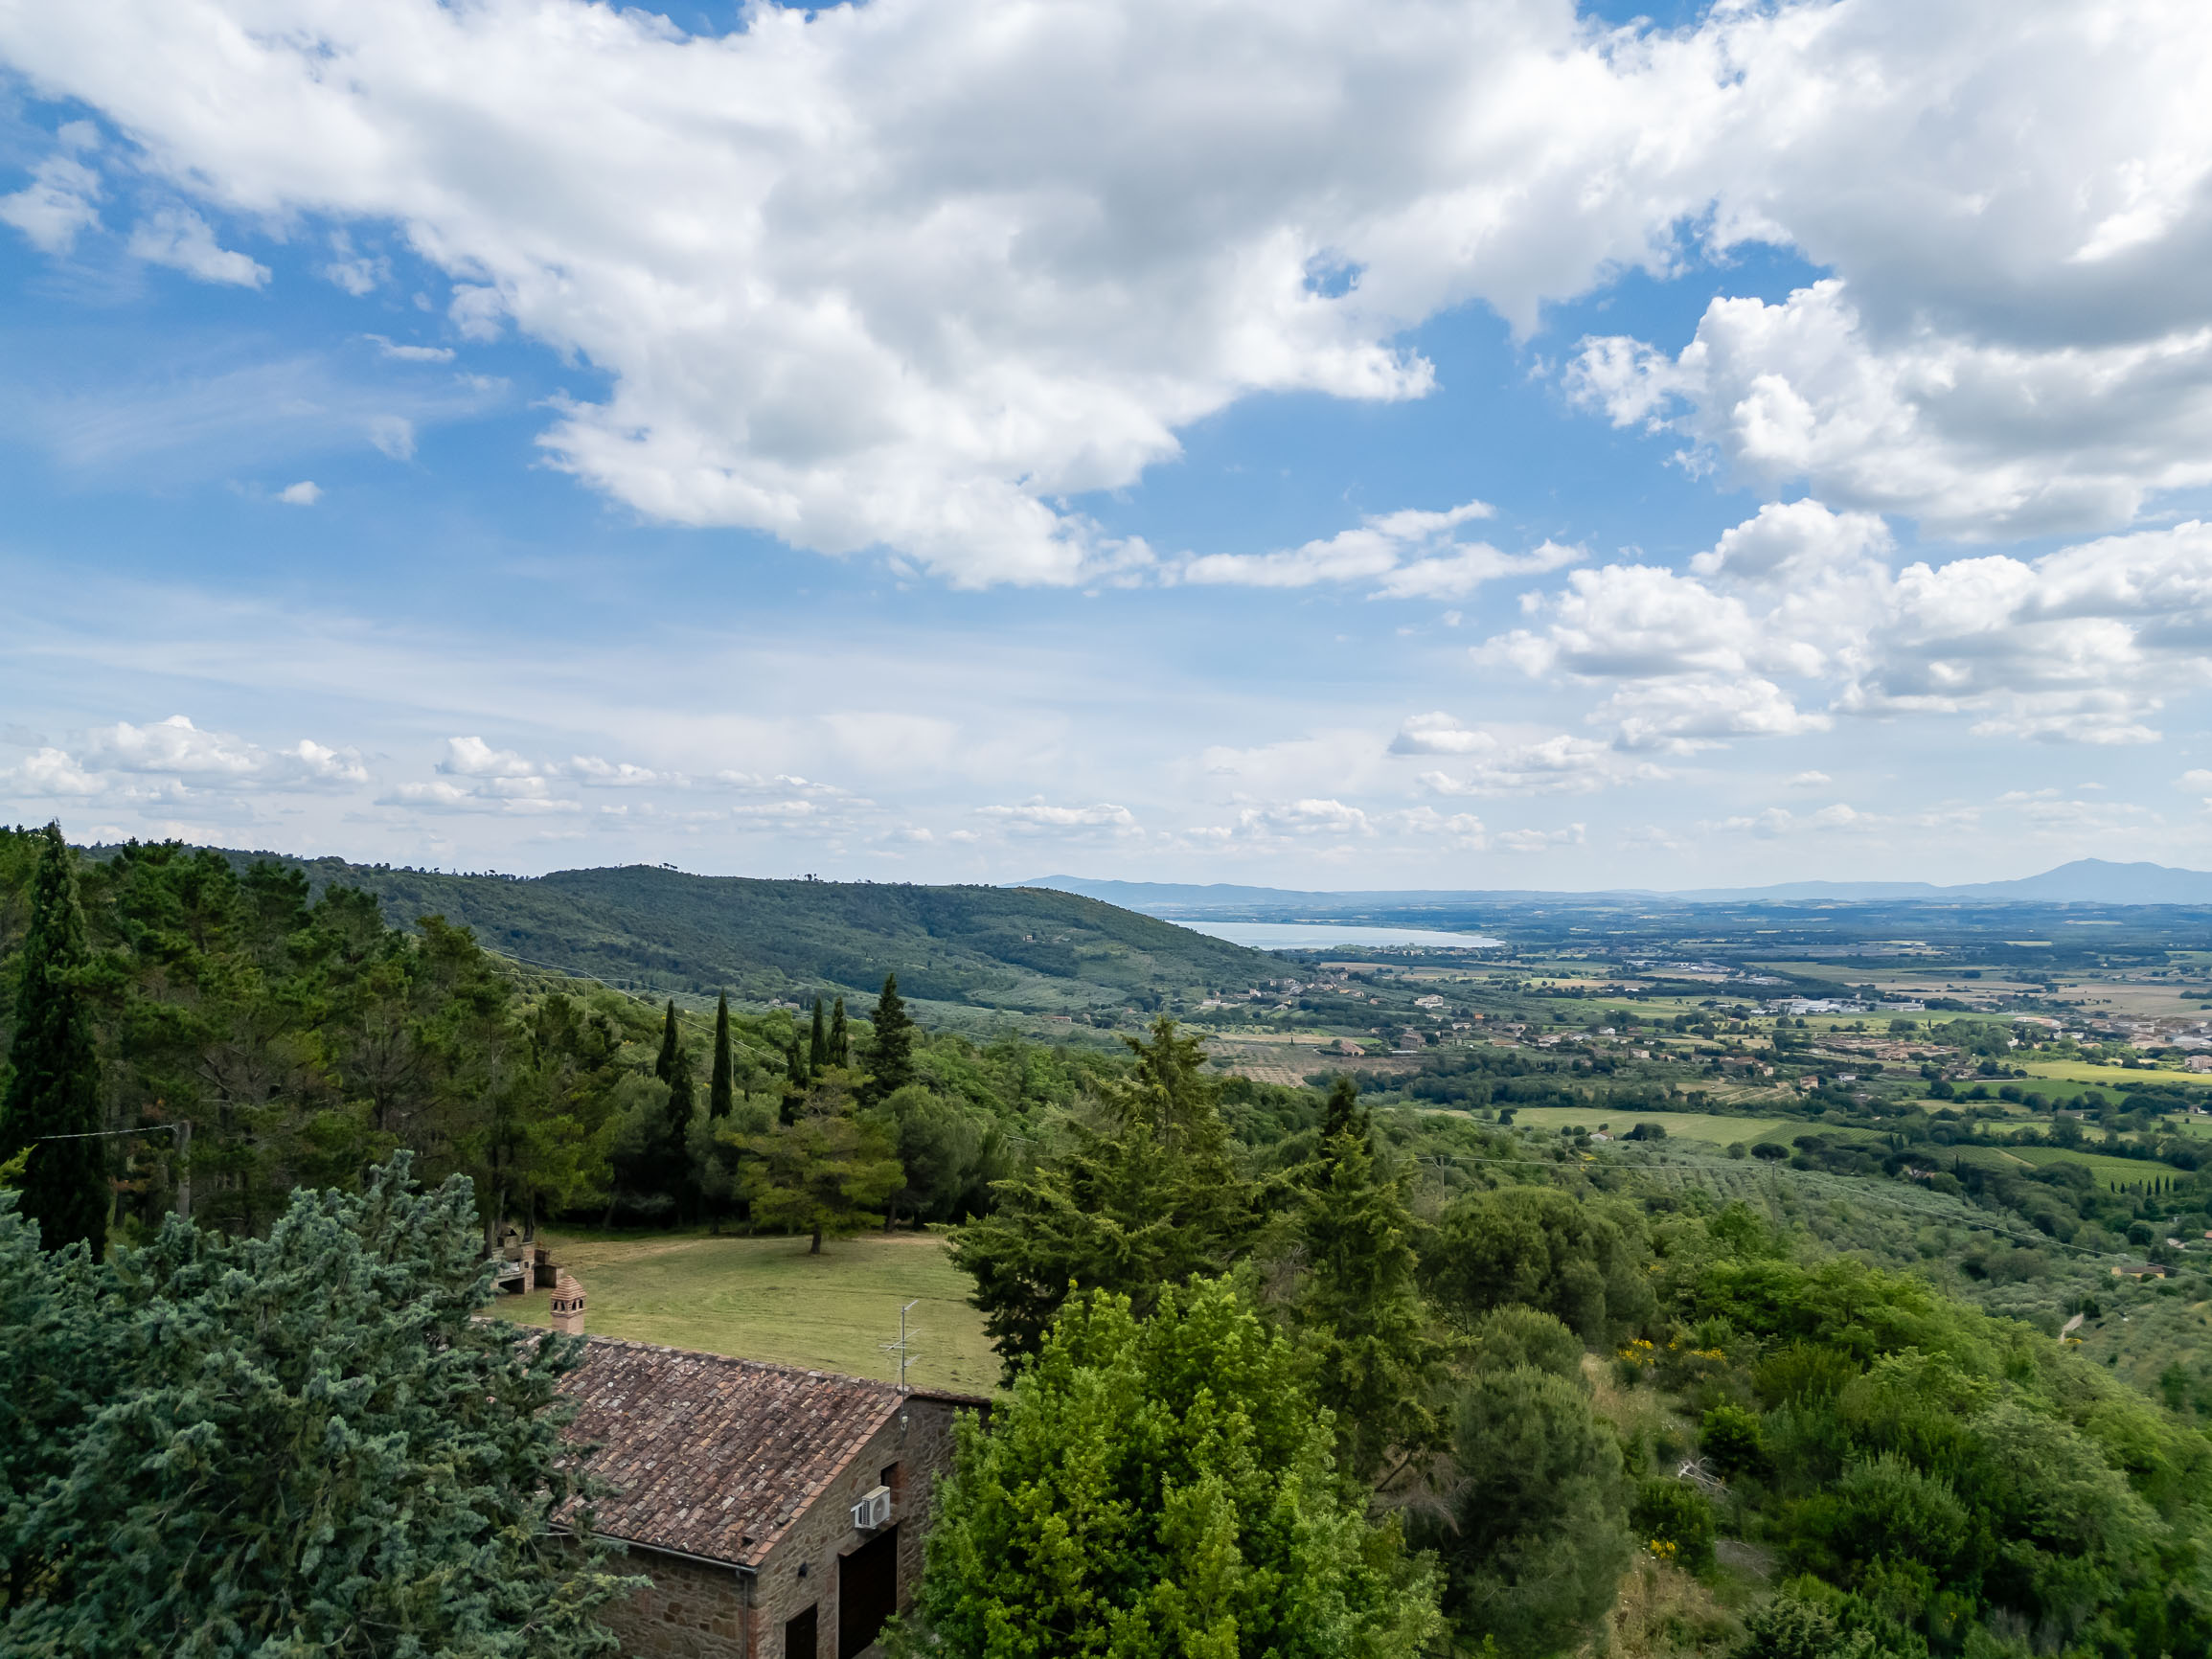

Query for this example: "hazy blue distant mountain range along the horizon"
[1015,858,2212,918]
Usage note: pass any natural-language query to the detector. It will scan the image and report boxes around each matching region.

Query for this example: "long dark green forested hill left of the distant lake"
[176,850,1286,1013]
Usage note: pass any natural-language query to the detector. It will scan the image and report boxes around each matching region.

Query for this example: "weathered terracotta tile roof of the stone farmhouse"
[559,1336,985,1566]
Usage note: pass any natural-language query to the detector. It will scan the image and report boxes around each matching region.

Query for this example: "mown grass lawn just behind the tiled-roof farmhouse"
[491,1232,997,1394]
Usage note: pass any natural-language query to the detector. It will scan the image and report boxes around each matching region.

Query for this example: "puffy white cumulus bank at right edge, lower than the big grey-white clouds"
[1486,502,2212,750]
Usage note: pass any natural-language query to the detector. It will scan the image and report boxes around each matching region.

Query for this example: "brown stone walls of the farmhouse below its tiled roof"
[602,1398,982,1659]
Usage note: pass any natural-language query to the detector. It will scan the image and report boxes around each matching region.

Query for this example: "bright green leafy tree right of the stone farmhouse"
[902,1281,1438,1659]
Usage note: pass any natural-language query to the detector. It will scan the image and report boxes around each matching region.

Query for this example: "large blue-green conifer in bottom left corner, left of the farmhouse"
[0,1154,630,1659]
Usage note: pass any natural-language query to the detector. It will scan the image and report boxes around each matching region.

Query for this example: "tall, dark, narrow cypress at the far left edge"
[0,823,110,1254]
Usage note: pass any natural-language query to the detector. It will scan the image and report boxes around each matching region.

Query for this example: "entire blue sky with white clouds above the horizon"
[0,0,2212,889]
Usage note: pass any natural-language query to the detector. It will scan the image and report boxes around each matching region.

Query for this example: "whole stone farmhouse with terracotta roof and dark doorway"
[561,1336,989,1659]
